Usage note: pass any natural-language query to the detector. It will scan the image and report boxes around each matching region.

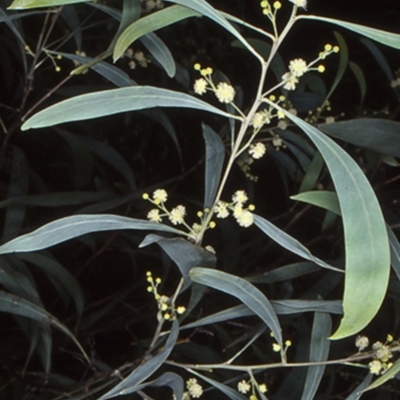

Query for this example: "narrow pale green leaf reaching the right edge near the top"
[296,15,400,49]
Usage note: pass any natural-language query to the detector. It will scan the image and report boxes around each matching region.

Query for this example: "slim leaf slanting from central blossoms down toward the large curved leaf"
[254,214,343,272]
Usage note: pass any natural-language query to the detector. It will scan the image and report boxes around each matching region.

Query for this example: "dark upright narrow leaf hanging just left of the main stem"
[203,125,225,209]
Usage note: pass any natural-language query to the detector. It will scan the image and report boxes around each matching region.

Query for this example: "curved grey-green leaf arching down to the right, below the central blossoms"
[189,268,282,346]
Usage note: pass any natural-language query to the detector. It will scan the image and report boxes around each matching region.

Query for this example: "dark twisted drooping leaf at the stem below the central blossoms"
[139,233,217,290]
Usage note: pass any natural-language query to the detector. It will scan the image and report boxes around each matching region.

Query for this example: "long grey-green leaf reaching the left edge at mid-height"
[0,214,183,254]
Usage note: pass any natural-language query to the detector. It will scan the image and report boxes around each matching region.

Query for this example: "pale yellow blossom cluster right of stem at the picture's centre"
[214,190,255,228]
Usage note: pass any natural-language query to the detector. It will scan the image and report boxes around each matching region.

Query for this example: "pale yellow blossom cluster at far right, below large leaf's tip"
[355,335,399,375]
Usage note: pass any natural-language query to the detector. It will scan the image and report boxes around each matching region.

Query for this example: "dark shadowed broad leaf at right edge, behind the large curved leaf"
[318,118,400,157]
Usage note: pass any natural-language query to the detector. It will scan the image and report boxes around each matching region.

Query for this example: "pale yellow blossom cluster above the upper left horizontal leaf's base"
[193,63,236,104]
